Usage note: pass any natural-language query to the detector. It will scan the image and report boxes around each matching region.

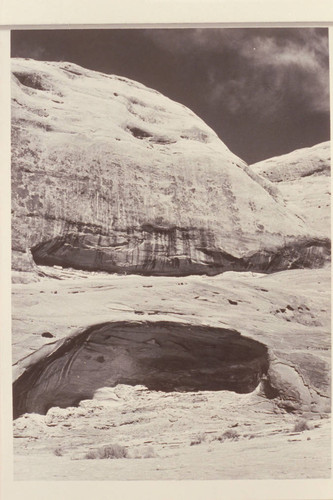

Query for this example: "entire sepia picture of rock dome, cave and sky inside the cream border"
[11,28,331,481]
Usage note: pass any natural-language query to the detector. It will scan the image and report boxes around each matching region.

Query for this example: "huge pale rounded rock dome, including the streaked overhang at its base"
[12,59,330,275]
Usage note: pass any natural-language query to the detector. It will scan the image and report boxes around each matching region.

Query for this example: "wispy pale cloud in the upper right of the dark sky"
[146,28,329,120]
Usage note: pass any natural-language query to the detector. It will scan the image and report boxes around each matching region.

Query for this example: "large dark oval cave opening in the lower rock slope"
[13,321,268,418]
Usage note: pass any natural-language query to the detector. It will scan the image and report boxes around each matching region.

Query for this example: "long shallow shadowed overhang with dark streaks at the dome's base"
[31,231,330,276]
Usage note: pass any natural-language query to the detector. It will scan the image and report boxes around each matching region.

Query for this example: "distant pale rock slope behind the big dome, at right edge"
[250,142,331,238]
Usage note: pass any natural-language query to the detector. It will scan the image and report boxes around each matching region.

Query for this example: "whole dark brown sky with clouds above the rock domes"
[11,28,330,163]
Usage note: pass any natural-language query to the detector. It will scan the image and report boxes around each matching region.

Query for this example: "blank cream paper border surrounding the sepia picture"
[0,0,333,500]
